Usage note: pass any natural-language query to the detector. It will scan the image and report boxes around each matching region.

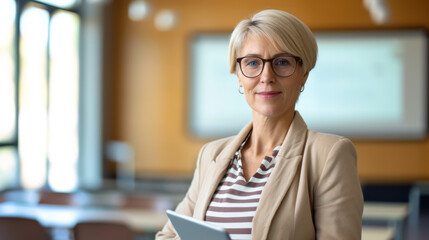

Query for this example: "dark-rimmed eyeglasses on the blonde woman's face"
[237,55,302,78]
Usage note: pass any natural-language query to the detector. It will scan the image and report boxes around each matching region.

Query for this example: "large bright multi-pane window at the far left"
[0,0,81,191]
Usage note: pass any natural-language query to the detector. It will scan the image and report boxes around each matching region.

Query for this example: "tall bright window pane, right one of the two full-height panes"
[48,11,79,191]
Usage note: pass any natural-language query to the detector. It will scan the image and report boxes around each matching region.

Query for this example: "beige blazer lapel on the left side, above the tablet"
[194,123,252,220]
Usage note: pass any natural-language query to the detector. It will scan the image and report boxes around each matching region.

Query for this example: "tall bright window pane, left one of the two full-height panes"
[19,7,49,188]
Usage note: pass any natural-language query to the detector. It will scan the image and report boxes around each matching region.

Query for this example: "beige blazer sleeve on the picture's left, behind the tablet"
[155,145,206,240]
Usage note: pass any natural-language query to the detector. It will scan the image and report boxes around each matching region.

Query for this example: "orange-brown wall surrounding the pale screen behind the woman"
[107,0,429,182]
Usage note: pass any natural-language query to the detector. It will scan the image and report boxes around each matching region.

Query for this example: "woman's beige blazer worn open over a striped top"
[156,112,363,240]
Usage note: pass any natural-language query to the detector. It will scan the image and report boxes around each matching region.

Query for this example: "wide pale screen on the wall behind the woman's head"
[189,30,428,140]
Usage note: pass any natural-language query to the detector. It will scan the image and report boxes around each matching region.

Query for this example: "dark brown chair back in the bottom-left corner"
[0,217,48,240]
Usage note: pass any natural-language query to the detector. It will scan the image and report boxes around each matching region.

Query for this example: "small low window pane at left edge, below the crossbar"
[0,147,18,191]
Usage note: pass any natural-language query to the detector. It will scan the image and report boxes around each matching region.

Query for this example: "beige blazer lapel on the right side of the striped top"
[252,112,307,239]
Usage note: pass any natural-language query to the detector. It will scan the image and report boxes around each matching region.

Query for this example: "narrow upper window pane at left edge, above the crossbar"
[0,0,16,142]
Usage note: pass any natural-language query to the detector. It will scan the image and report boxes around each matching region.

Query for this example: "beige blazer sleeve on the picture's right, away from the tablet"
[314,138,363,240]
